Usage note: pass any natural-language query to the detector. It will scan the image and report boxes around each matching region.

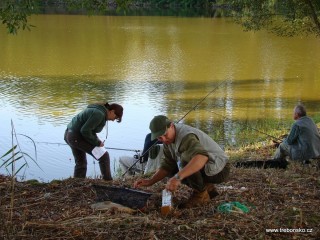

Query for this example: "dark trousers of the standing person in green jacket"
[64,130,112,180]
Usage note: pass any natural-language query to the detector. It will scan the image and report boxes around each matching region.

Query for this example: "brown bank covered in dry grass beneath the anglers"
[0,141,320,239]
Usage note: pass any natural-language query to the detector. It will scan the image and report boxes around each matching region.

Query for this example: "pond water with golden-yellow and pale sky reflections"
[0,15,320,181]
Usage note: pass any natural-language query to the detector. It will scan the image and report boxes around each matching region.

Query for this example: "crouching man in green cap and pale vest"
[134,115,230,207]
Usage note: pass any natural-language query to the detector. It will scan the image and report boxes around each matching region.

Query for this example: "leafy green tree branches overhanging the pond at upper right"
[222,0,320,37]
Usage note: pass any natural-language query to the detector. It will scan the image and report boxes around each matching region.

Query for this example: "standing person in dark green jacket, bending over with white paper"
[64,103,123,180]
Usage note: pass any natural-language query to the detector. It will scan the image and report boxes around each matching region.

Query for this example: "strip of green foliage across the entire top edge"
[0,0,320,37]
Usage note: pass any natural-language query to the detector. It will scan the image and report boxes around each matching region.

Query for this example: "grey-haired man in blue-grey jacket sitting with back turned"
[274,104,320,163]
